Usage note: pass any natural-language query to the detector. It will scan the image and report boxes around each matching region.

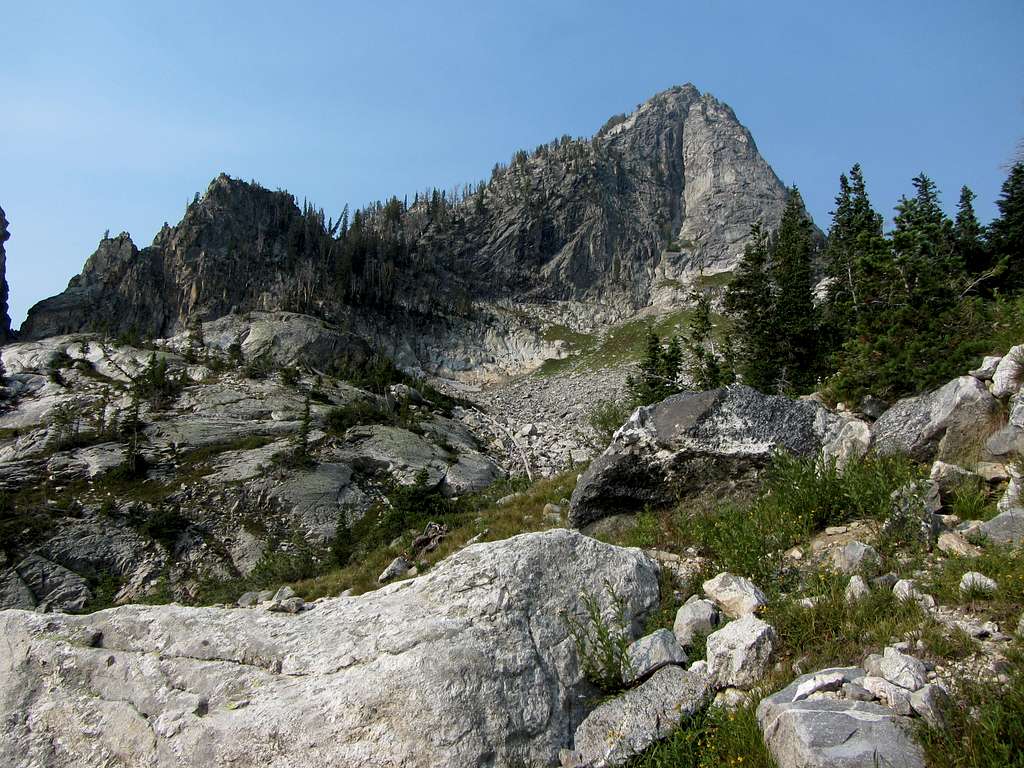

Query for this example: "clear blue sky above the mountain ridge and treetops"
[0,0,1024,325]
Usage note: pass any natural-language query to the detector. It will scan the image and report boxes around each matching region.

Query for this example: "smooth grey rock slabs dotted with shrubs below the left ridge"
[0,331,503,610]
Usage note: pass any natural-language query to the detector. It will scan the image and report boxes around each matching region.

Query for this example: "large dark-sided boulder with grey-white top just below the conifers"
[569,385,846,527]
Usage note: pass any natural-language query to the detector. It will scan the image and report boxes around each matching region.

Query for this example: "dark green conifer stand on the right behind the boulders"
[630,162,1024,403]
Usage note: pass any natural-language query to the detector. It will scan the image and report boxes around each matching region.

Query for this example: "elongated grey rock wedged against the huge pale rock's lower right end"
[573,667,712,768]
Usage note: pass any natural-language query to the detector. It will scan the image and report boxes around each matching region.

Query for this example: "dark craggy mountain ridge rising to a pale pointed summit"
[22,85,785,364]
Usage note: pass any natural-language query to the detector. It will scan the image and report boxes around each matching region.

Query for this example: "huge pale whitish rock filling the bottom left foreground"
[0,529,658,768]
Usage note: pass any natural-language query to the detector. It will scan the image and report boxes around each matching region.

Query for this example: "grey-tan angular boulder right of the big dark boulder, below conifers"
[871,376,999,462]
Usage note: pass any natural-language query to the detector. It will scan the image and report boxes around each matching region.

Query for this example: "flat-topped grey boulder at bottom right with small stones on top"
[757,668,925,768]
